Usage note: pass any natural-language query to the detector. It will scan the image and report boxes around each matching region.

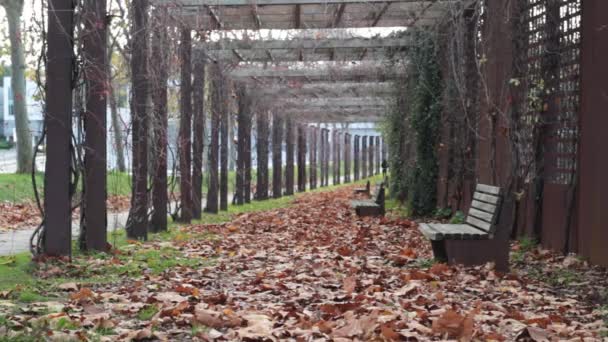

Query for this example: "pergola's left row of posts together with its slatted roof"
[36,0,456,255]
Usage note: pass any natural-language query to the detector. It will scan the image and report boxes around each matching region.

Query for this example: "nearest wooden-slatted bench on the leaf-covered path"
[419,184,510,271]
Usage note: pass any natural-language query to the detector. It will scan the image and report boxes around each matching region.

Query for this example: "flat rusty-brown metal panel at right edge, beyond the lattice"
[578,0,608,266]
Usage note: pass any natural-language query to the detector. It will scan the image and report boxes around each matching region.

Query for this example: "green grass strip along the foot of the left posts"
[0,176,381,310]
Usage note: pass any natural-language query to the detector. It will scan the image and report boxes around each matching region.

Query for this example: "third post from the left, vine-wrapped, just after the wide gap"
[124,0,149,240]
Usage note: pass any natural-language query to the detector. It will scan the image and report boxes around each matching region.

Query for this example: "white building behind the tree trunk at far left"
[0,77,43,143]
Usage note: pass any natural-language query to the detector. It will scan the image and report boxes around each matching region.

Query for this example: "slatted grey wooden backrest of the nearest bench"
[466,184,502,234]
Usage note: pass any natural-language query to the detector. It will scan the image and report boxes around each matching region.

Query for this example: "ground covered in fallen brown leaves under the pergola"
[0,188,606,341]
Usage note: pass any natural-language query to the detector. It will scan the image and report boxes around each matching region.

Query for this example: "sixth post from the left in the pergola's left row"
[191,55,205,219]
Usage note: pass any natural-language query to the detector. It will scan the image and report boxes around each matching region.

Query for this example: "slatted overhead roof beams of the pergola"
[152,0,459,123]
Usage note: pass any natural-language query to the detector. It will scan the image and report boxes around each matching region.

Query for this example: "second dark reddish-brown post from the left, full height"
[80,0,108,251]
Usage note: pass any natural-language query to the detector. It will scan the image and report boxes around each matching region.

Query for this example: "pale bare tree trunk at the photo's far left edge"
[4,0,34,173]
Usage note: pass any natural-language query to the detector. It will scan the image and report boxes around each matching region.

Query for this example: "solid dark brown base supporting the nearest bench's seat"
[445,237,509,272]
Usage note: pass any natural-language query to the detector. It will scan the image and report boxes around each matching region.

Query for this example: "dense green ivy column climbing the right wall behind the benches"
[384,30,443,216]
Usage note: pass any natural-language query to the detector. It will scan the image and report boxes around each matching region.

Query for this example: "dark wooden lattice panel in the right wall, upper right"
[519,0,581,185]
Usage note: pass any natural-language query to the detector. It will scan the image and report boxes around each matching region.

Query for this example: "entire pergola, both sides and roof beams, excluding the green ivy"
[39,0,608,264]
